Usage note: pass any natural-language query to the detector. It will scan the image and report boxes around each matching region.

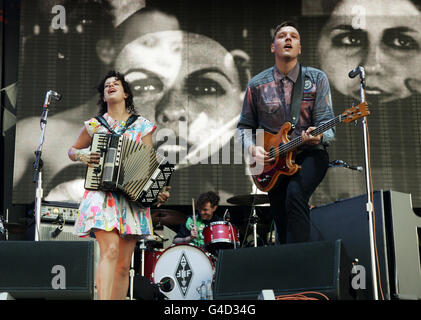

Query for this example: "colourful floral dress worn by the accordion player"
[73,113,156,238]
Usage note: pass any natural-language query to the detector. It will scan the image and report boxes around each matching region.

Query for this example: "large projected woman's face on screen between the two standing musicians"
[115,31,242,162]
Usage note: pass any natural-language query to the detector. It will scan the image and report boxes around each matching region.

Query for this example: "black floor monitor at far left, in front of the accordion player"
[0,241,94,299]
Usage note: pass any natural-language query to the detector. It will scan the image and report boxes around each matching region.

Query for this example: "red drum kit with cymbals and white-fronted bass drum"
[131,194,269,300]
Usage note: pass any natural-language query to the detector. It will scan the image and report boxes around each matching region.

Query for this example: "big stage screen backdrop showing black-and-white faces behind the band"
[13,0,421,206]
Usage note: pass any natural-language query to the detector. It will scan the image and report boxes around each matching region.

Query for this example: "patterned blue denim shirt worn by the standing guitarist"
[237,63,335,150]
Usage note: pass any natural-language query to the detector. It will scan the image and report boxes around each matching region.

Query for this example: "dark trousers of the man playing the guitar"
[268,149,329,244]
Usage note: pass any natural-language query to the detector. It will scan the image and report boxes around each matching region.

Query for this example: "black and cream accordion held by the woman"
[85,133,174,207]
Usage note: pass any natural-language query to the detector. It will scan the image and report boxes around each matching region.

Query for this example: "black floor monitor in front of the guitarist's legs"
[214,240,352,300]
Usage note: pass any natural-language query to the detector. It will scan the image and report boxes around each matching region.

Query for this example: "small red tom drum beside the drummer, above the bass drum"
[203,221,240,251]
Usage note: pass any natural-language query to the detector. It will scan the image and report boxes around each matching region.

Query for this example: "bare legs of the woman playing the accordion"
[95,230,137,300]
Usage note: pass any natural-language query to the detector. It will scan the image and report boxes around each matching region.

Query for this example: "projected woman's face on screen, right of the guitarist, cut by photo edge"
[317,0,421,102]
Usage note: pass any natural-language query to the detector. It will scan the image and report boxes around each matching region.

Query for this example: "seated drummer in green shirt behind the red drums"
[173,191,223,249]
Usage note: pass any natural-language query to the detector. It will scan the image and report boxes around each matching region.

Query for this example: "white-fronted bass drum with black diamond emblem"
[152,244,215,300]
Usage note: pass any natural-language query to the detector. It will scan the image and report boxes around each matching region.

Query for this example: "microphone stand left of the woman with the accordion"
[33,90,60,241]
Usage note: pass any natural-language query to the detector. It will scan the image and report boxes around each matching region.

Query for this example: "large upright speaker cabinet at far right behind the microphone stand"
[310,191,421,300]
